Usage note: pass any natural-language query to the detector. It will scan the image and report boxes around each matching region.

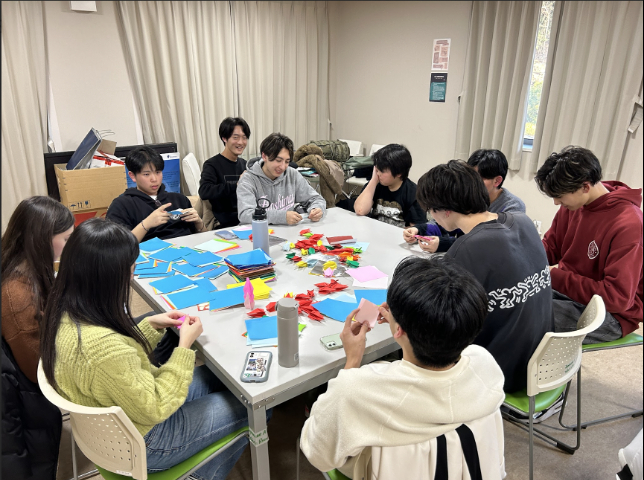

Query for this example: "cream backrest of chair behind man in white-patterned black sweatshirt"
[527,295,606,397]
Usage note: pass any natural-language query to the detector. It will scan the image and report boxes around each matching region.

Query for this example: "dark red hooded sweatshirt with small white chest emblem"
[543,181,642,335]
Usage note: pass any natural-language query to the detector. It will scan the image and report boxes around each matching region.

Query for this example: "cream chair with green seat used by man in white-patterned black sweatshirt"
[502,295,606,480]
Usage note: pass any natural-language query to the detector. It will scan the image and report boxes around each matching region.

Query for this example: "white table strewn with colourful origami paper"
[133,208,422,480]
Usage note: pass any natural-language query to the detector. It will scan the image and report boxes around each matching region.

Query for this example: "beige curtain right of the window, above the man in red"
[530,1,643,179]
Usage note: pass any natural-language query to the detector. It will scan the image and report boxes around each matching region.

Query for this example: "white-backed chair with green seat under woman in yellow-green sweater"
[38,361,248,480]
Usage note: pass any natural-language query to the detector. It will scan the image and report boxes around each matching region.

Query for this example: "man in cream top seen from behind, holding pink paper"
[300,258,506,480]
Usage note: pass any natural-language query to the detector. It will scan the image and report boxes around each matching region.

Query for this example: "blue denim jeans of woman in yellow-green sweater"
[144,365,272,480]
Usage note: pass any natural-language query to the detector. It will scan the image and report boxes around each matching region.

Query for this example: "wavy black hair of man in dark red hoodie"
[534,145,602,198]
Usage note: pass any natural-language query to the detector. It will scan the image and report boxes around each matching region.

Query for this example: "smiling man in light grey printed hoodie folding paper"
[237,133,326,225]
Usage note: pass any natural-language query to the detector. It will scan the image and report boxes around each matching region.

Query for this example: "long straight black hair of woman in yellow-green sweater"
[40,218,152,388]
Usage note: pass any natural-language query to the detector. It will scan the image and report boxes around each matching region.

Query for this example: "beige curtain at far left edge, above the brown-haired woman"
[2,2,47,232]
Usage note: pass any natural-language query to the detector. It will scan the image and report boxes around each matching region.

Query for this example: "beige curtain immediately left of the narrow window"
[456,1,541,170]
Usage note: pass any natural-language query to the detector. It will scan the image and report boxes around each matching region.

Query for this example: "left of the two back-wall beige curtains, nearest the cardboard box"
[116,2,238,164]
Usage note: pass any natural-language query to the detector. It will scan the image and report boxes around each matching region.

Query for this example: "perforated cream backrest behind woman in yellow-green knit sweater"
[38,360,148,480]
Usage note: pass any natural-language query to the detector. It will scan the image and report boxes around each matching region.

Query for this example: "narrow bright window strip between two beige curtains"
[523,0,555,150]
